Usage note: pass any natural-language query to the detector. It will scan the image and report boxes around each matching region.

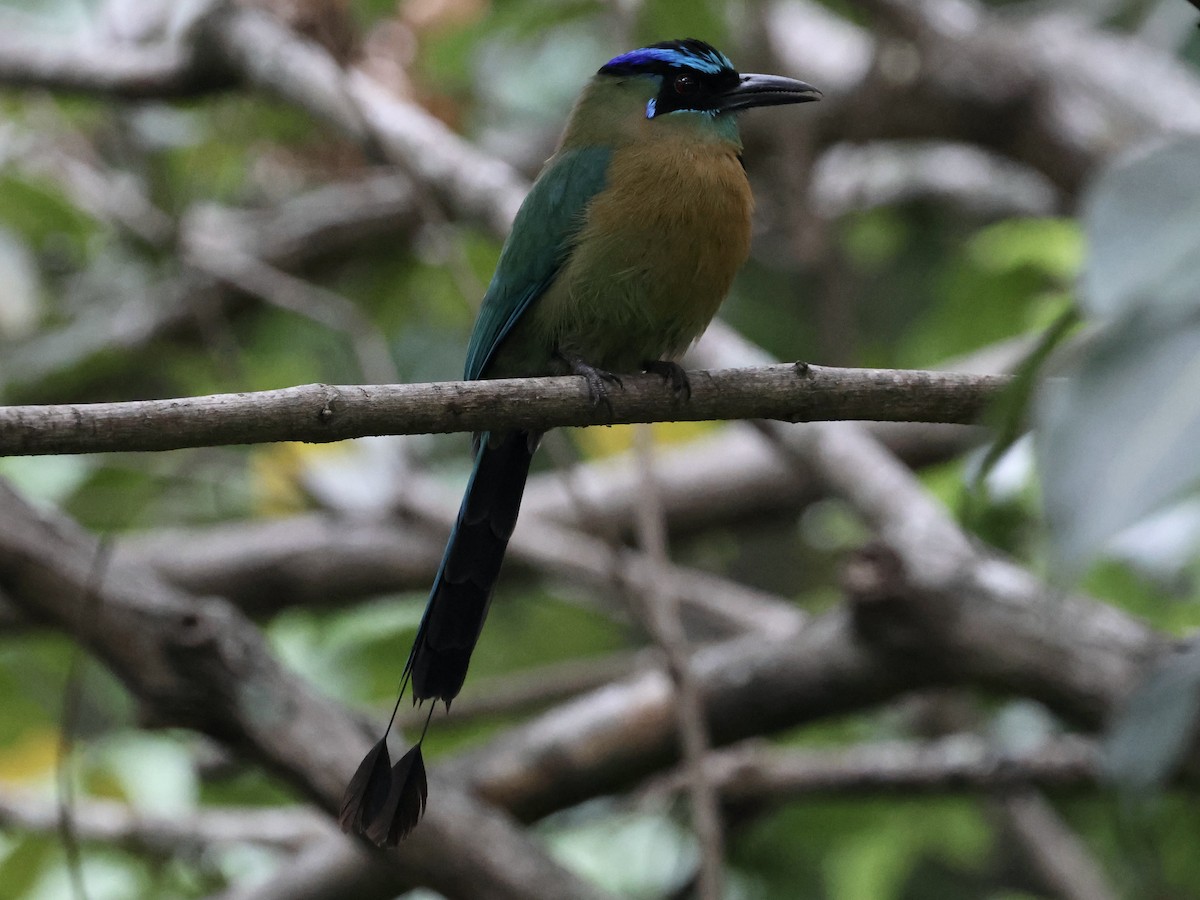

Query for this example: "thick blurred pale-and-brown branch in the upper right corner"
[830,0,1200,193]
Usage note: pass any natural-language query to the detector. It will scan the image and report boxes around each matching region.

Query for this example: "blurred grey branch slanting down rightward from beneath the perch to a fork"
[709,328,1163,722]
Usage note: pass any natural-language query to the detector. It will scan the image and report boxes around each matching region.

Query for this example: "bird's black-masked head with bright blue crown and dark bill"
[595,38,821,119]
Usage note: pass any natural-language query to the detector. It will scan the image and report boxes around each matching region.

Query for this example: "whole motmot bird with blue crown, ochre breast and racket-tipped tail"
[341,38,820,845]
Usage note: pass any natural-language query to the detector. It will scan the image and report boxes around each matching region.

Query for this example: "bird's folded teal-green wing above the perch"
[466,146,612,379]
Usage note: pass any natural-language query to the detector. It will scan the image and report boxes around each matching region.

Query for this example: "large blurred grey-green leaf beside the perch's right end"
[1037,140,1200,577]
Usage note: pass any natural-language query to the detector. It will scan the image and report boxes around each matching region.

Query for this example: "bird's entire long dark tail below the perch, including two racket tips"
[340,431,540,846]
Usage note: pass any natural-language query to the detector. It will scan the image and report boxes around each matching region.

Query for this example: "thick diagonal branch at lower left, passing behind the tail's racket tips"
[0,485,602,900]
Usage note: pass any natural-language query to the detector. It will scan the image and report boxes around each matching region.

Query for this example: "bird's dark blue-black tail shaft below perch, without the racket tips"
[404,431,539,707]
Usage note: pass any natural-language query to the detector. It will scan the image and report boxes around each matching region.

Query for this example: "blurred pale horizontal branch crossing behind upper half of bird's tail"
[84,408,983,619]
